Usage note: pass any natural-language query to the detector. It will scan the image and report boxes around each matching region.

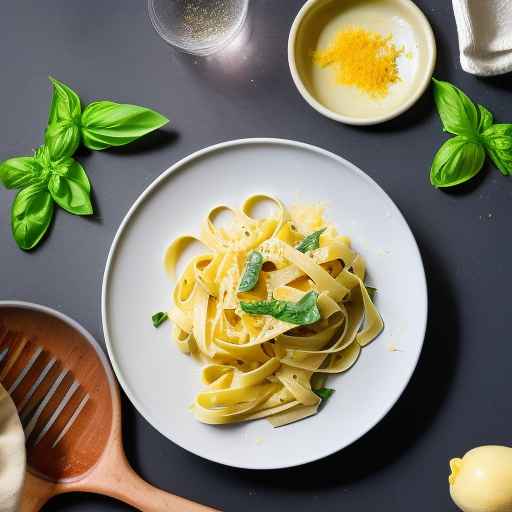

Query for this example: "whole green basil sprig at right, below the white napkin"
[430,78,512,188]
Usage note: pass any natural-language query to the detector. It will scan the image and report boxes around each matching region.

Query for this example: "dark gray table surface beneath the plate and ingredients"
[0,0,512,512]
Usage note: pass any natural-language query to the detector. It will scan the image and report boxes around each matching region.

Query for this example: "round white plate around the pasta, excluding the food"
[102,139,427,469]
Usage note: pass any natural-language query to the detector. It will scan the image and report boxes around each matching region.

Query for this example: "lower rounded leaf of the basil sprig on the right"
[430,135,485,188]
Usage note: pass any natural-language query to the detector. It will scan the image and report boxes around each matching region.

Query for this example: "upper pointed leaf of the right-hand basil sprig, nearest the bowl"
[432,78,479,136]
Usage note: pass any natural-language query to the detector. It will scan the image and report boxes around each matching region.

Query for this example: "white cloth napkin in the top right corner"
[452,0,512,76]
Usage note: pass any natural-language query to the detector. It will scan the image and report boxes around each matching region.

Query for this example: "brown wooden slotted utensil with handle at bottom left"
[0,302,217,512]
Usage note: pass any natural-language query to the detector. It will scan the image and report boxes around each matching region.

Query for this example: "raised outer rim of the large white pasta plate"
[101,137,428,470]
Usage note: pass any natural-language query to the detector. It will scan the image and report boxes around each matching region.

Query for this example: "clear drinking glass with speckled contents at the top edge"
[147,0,249,56]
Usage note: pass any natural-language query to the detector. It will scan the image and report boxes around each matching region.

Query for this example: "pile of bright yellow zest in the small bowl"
[313,27,404,98]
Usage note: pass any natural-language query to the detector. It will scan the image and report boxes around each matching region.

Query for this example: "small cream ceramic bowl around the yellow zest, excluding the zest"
[288,0,436,125]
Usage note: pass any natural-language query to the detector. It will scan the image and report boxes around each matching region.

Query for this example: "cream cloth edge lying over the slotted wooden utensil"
[0,384,25,512]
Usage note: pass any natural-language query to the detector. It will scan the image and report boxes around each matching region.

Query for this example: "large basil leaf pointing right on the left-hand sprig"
[81,101,169,150]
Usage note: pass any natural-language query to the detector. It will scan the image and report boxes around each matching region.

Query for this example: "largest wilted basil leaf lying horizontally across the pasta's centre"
[240,291,320,325]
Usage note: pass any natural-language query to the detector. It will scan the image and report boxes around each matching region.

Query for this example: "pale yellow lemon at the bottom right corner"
[448,446,512,512]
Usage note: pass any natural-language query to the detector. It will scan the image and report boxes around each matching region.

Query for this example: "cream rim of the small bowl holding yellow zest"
[288,0,437,126]
